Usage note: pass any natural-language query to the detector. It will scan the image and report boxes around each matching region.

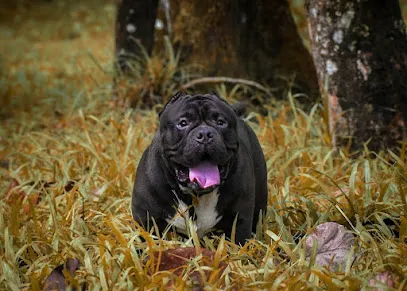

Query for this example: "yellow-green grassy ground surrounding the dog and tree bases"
[0,0,407,290]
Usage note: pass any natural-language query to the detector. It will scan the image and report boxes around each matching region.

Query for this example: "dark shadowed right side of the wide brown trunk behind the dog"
[237,0,319,98]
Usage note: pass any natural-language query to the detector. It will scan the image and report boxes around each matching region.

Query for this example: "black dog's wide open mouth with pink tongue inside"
[175,161,229,192]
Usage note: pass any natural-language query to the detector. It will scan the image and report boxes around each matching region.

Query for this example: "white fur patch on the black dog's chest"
[166,189,222,237]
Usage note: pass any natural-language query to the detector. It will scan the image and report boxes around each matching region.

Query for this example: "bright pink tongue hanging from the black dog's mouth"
[189,162,220,189]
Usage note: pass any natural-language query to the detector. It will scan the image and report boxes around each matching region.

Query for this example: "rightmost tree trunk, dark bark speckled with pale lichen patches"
[307,0,407,151]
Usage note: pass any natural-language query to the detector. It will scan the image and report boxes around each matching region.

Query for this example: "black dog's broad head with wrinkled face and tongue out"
[159,93,239,194]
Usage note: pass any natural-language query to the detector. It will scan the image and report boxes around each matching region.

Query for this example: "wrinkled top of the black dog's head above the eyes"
[159,92,234,117]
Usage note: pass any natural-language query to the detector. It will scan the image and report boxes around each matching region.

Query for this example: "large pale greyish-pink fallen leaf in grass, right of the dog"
[305,222,354,271]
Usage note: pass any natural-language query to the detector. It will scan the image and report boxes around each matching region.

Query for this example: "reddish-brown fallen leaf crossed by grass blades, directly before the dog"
[145,247,227,290]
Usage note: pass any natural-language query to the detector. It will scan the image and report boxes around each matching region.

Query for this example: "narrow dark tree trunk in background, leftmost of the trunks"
[116,0,158,71]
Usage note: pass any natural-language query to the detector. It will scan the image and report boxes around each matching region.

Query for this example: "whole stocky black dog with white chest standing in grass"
[132,93,267,244]
